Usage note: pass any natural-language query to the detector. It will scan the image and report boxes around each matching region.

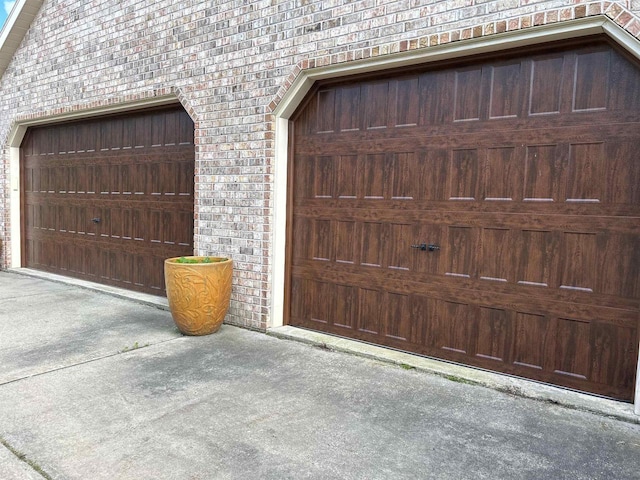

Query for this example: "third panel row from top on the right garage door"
[294,227,639,318]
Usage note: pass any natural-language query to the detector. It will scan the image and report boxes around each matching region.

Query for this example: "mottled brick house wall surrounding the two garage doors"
[0,0,640,330]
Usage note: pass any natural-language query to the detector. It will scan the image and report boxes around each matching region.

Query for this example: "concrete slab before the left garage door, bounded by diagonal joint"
[0,272,181,384]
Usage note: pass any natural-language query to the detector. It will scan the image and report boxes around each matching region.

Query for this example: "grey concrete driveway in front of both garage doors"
[0,272,640,480]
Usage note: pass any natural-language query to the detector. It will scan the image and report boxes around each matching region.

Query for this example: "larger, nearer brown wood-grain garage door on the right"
[288,40,640,400]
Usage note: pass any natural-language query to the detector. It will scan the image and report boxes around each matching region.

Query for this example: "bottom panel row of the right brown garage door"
[294,272,637,396]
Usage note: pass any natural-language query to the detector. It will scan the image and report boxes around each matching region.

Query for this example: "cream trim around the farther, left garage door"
[8,95,184,268]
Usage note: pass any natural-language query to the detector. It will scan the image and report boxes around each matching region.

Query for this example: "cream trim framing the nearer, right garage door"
[269,16,640,415]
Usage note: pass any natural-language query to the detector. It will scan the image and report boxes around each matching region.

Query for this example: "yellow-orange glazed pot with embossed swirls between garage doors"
[164,256,233,335]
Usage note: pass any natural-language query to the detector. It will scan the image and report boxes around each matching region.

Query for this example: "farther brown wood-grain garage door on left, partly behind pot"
[22,107,194,295]
